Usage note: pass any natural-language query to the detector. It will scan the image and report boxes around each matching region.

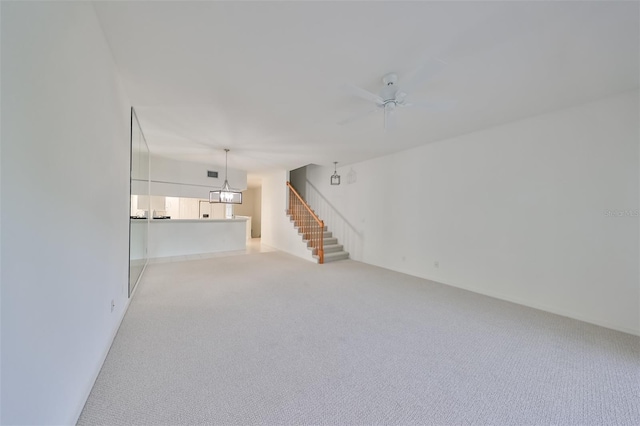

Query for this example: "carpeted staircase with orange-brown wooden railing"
[287,182,349,263]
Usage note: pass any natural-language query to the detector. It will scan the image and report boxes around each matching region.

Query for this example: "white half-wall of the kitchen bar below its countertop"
[149,217,247,259]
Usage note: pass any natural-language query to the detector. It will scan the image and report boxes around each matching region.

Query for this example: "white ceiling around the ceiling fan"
[95,1,639,180]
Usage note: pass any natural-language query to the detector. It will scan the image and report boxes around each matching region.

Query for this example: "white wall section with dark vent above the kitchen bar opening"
[151,152,247,200]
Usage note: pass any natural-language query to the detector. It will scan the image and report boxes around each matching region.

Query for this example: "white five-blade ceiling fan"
[338,59,456,130]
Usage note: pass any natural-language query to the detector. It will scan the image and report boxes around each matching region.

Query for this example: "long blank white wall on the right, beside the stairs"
[307,91,640,334]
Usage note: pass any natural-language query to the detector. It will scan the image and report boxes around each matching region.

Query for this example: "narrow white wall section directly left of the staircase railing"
[261,170,315,262]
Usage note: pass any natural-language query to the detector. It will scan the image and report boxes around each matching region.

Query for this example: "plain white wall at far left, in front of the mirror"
[0,2,130,425]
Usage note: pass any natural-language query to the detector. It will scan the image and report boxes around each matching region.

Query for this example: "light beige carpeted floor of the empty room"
[79,252,640,425]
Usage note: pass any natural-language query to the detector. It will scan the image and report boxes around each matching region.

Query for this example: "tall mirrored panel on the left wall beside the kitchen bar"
[129,108,150,297]
